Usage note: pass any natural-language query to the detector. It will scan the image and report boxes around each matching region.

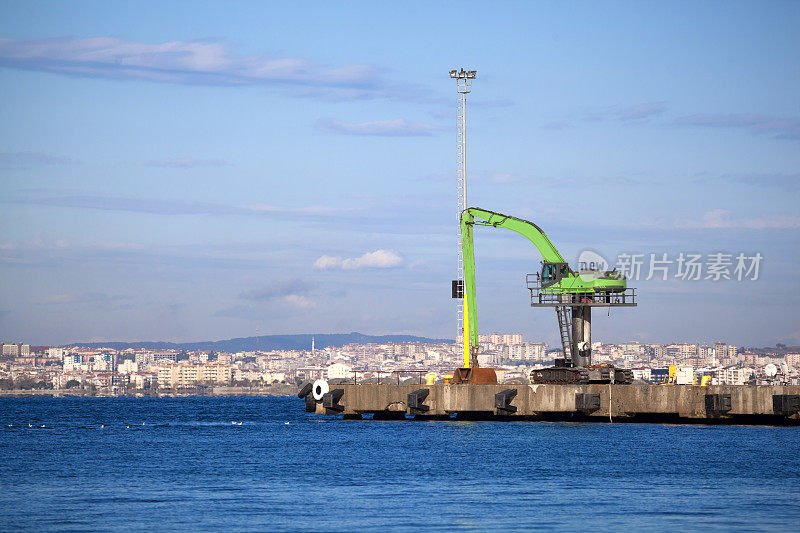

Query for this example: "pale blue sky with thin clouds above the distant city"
[0,2,800,346]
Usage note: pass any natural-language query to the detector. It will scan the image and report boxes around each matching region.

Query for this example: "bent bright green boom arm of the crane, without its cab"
[461,207,566,354]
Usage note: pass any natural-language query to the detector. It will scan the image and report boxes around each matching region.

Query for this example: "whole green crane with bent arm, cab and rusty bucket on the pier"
[454,207,628,382]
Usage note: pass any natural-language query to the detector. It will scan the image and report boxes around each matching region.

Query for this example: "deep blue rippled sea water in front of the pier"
[0,397,800,531]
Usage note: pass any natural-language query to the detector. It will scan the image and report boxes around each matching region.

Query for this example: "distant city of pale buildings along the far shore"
[0,333,800,395]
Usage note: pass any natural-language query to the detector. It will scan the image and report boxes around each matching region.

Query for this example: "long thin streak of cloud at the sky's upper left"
[0,37,421,100]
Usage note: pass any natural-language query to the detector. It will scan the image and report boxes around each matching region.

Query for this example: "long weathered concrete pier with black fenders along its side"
[306,384,800,425]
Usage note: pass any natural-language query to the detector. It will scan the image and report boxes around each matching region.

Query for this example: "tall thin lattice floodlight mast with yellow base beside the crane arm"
[450,68,478,368]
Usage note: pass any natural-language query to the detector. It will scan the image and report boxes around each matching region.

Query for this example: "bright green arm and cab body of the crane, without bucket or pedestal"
[461,207,627,355]
